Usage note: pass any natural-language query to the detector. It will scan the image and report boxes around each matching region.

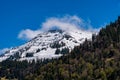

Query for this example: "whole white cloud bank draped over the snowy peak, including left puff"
[18,15,98,40]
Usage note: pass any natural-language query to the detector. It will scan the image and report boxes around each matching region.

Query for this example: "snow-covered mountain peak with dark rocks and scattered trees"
[0,29,92,61]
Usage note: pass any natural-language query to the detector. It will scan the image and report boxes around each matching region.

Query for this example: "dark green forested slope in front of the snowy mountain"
[0,17,120,80]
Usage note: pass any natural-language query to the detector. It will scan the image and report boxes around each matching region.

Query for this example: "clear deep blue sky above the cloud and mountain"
[0,0,120,49]
